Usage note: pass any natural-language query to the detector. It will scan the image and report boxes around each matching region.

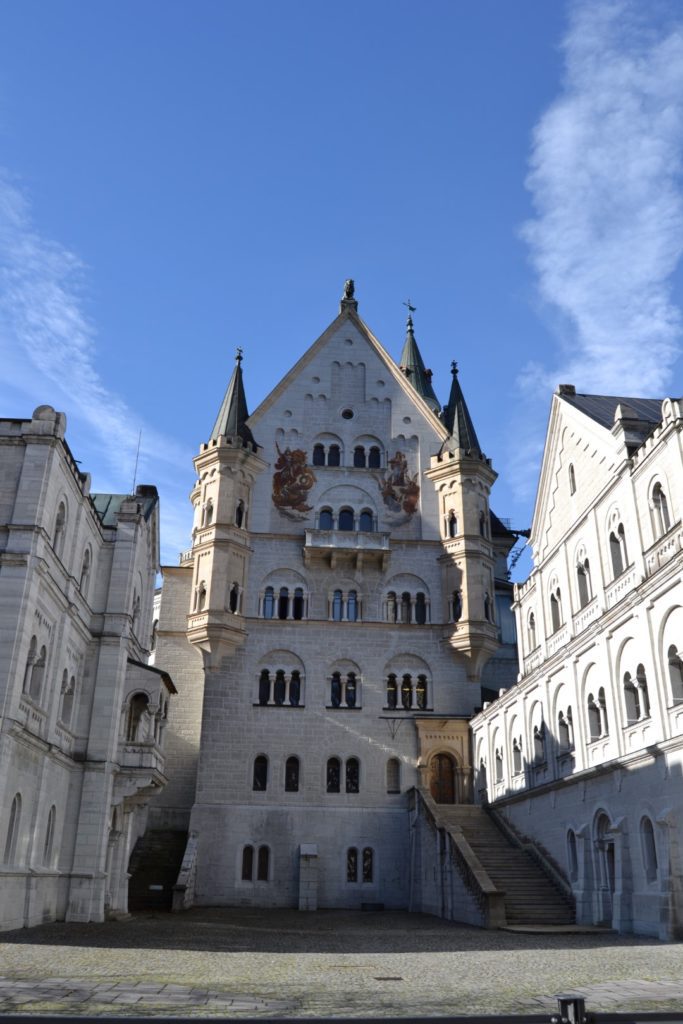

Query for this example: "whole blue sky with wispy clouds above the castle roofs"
[0,0,683,562]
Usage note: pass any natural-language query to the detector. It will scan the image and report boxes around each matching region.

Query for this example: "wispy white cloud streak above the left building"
[0,173,191,560]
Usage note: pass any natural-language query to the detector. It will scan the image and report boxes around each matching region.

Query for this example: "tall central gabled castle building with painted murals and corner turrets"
[151,288,516,909]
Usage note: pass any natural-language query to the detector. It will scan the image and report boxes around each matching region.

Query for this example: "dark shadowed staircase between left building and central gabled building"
[128,828,187,911]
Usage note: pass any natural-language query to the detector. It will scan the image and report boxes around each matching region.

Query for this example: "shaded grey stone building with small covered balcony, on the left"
[0,406,173,929]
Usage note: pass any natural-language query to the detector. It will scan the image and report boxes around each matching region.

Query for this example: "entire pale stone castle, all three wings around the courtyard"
[0,282,683,939]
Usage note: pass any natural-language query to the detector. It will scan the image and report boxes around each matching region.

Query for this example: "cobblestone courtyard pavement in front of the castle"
[0,909,683,1017]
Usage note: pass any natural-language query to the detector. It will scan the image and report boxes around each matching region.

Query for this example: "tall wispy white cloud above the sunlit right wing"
[511,0,683,503]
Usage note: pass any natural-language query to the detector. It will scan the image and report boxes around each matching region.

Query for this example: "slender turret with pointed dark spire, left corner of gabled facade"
[187,349,265,656]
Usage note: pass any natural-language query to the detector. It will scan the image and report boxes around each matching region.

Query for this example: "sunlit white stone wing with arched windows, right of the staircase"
[472,386,683,939]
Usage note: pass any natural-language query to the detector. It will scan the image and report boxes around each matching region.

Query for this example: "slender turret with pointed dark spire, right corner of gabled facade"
[426,362,499,681]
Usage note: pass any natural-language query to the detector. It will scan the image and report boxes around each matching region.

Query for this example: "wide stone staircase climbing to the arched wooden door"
[432,804,575,926]
